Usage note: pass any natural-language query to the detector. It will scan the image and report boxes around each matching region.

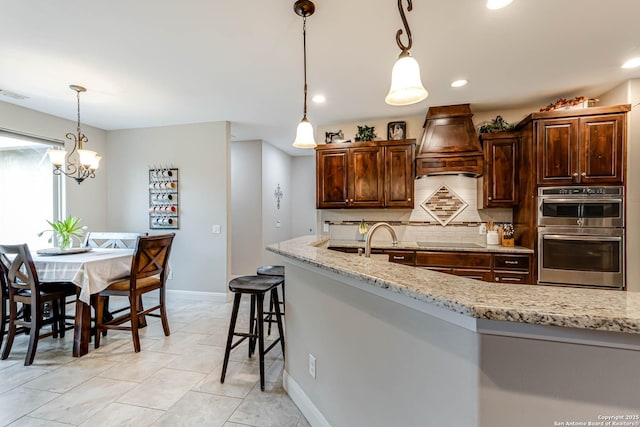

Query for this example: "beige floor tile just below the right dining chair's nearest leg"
[100,351,177,383]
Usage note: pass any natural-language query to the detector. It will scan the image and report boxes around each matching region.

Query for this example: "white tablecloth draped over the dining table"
[31,249,133,304]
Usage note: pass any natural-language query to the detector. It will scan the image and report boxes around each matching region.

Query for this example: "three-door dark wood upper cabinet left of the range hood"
[316,140,415,209]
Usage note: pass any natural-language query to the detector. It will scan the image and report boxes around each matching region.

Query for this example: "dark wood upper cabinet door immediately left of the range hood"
[384,144,414,208]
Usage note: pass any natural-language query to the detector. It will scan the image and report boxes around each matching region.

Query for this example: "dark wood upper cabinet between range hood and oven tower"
[480,132,520,208]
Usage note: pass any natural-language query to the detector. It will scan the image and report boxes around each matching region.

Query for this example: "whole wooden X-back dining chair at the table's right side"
[94,233,175,353]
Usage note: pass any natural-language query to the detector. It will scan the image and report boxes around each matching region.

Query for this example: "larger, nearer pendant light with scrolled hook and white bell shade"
[384,0,429,105]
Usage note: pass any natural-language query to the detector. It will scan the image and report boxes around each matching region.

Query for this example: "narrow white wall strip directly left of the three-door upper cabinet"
[291,152,320,237]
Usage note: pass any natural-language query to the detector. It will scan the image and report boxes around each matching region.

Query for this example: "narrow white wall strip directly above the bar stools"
[231,141,263,276]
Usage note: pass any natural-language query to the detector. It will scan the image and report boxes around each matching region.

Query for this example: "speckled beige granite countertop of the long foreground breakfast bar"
[267,236,640,334]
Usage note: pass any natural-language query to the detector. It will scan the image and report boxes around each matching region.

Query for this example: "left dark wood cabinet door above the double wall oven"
[537,118,580,185]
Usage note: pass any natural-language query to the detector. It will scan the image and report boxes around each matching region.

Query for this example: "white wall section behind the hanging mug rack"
[107,122,230,293]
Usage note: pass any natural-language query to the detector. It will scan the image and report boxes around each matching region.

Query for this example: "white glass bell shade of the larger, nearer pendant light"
[384,53,429,105]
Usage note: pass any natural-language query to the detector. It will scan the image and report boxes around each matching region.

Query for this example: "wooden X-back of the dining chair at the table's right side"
[131,233,176,289]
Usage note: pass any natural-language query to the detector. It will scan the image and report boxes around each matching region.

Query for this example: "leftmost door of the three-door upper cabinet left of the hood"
[316,149,349,208]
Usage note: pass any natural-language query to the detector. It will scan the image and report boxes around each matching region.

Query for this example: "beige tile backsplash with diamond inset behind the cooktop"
[319,175,512,244]
